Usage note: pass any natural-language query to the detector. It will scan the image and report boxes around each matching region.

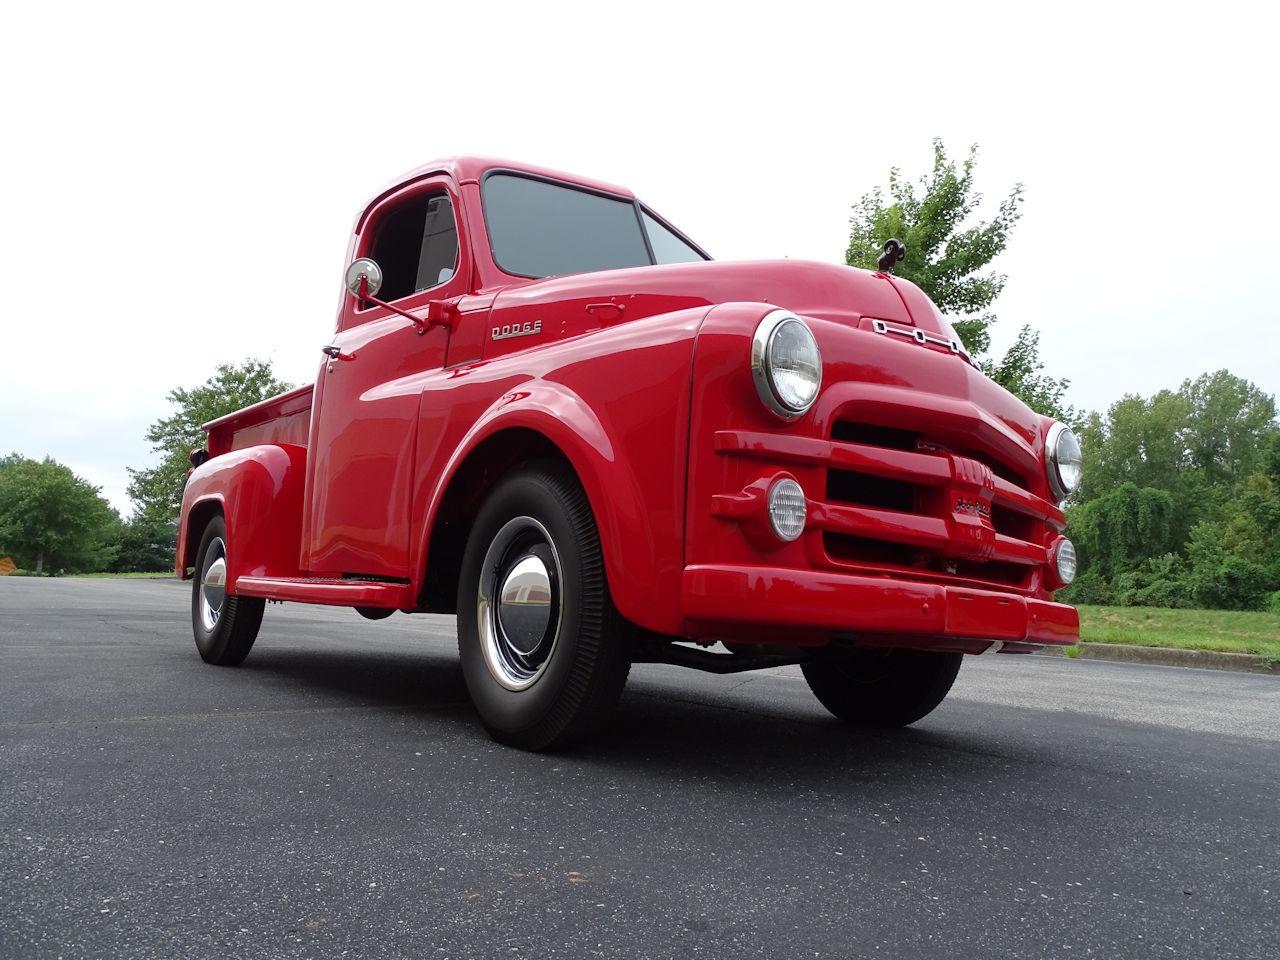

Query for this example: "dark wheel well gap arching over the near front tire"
[420,428,573,613]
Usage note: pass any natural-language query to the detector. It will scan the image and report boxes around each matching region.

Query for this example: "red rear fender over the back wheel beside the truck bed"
[178,443,307,594]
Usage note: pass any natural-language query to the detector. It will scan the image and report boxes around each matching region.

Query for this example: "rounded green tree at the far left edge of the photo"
[0,453,119,573]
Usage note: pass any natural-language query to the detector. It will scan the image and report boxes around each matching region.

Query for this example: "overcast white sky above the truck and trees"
[0,0,1280,512]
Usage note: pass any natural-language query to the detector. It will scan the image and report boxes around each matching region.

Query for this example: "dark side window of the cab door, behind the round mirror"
[369,193,458,301]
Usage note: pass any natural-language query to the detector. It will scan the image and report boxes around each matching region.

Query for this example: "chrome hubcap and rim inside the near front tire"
[476,517,562,690]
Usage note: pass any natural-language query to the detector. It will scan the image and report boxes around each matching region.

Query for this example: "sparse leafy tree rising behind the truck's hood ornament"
[845,140,1075,421]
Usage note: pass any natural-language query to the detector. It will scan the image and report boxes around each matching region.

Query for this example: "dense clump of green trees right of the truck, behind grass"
[1069,370,1280,609]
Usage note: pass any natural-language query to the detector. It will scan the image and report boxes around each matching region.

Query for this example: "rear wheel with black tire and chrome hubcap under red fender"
[191,517,266,667]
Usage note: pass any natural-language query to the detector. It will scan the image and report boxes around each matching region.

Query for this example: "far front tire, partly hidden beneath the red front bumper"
[801,649,964,727]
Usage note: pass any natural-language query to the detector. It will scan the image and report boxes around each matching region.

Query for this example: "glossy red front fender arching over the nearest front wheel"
[415,310,705,634]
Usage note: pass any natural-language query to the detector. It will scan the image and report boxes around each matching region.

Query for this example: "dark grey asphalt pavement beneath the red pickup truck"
[0,577,1280,960]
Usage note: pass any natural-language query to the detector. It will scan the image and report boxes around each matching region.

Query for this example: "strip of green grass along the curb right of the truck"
[1079,605,1280,660]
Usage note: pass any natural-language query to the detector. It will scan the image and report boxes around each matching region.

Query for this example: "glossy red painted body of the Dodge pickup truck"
[179,159,1079,652]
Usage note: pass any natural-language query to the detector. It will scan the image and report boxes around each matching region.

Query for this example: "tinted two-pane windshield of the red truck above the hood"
[484,174,707,276]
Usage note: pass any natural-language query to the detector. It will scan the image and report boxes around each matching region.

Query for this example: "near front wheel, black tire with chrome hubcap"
[458,463,631,750]
